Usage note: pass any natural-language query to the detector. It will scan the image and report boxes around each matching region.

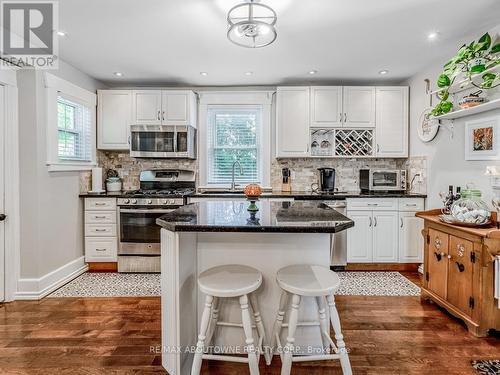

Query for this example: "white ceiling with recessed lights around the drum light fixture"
[59,0,500,86]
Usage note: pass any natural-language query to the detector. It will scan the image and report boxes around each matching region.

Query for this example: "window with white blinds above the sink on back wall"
[207,106,262,185]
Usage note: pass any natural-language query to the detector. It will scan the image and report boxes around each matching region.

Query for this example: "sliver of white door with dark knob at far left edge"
[0,86,7,301]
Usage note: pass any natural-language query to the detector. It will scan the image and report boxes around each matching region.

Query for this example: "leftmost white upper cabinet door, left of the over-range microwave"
[97,90,132,150]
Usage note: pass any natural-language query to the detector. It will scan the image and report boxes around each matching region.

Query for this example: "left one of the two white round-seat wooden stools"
[191,264,270,375]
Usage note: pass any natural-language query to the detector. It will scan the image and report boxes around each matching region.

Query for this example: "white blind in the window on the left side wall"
[57,95,92,161]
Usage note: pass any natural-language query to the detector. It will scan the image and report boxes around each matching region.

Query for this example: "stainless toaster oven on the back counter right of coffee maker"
[359,169,406,191]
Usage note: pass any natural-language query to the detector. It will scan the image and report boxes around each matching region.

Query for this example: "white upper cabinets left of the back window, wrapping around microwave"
[97,90,197,150]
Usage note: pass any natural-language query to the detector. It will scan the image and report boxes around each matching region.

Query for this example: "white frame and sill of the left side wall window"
[45,73,97,172]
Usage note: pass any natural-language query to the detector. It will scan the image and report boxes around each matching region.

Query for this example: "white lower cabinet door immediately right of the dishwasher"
[347,211,373,263]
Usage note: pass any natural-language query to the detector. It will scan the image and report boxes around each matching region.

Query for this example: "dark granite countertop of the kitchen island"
[156,200,354,233]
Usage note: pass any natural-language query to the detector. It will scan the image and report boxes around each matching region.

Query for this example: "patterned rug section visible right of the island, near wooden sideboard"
[336,272,420,296]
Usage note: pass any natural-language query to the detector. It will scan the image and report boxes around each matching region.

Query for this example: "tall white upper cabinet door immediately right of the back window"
[276,87,309,157]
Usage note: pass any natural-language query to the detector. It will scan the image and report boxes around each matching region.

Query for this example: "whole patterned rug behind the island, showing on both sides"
[49,272,420,297]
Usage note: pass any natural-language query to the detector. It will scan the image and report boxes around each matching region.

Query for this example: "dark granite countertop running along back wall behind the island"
[79,191,427,200]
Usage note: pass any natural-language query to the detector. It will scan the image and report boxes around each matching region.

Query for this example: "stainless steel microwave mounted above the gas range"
[130,125,196,159]
